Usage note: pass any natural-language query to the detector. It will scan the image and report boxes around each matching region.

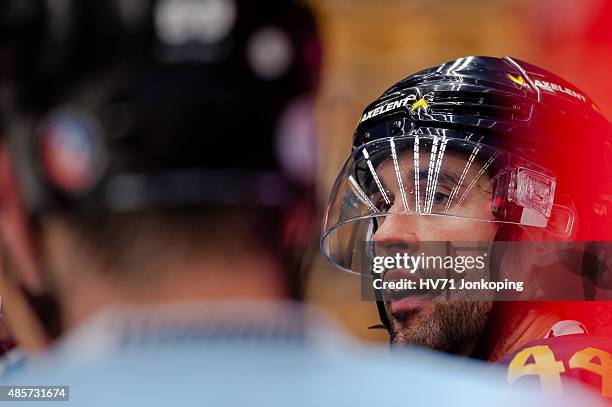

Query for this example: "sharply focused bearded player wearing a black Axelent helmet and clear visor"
[322,57,612,400]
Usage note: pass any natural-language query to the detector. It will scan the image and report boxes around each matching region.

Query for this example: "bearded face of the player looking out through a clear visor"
[374,152,497,353]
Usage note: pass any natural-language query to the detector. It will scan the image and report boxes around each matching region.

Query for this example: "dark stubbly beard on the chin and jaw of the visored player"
[390,301,493,354]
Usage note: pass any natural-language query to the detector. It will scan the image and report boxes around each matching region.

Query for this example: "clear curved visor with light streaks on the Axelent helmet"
[321,133,560,271]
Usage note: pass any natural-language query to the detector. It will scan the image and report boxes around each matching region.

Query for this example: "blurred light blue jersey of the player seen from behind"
[0,302,604,407]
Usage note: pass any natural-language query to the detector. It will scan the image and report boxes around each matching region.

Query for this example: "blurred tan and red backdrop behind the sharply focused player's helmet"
[307,0,612,341]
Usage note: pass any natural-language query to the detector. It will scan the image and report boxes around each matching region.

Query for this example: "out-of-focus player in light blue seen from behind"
[0,0,596,406]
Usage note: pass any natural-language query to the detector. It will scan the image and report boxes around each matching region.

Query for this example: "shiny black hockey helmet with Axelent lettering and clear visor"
[321,57,612,271]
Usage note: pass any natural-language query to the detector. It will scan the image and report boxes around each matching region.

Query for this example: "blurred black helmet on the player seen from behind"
[0,0,320,215]
